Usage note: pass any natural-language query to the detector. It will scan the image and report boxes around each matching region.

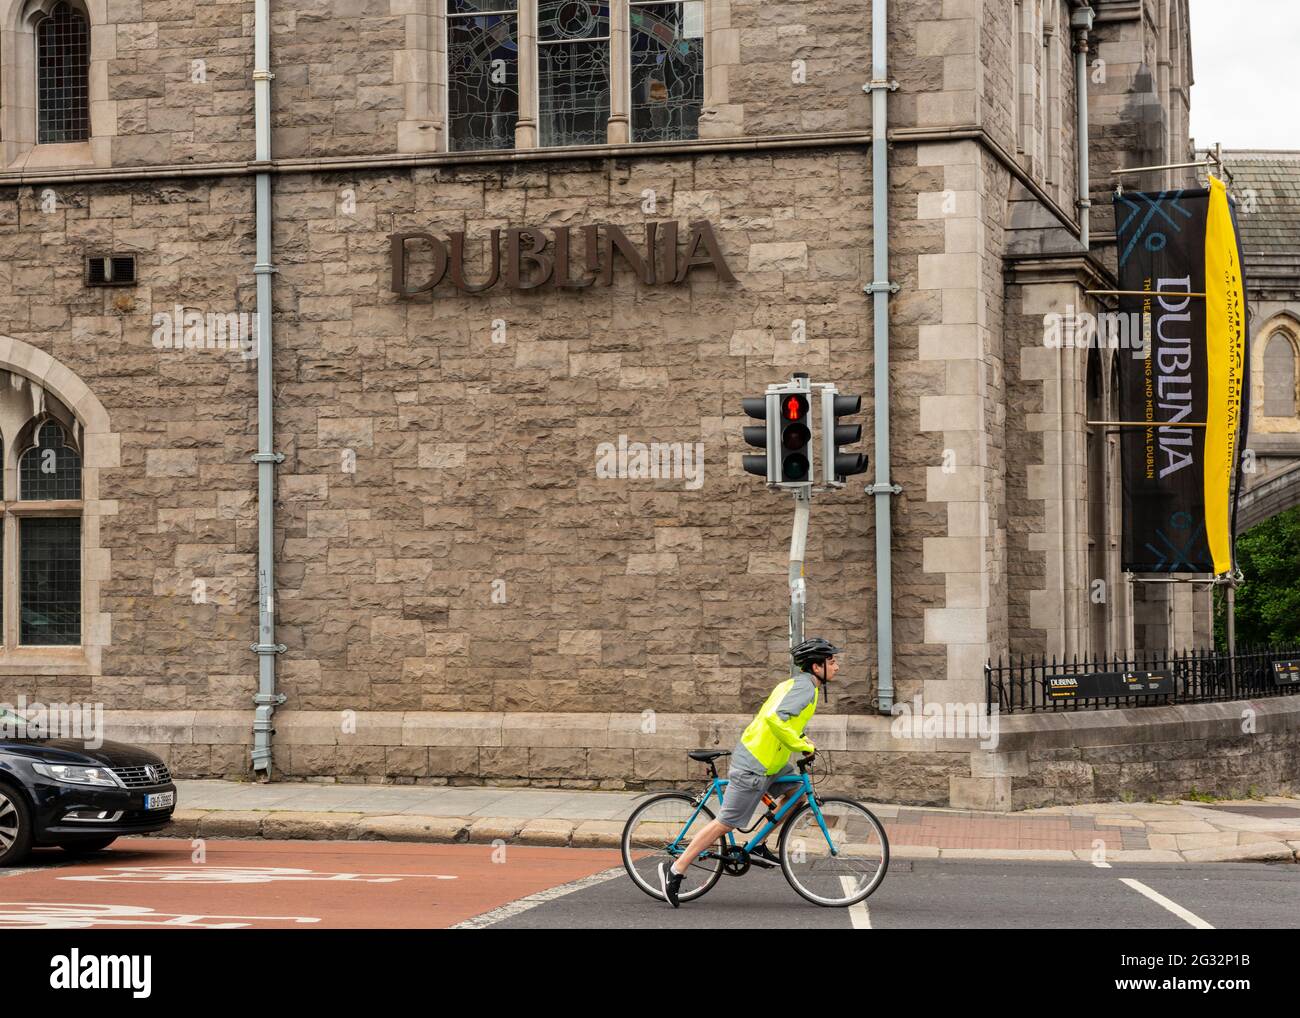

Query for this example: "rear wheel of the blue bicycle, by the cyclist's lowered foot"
[620,792,723,901]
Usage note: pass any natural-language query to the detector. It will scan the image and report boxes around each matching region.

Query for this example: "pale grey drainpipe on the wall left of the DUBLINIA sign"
[251,0,285,780]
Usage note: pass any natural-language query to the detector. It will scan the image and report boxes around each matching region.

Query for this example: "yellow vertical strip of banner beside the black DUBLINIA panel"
[1205,177,1245,575]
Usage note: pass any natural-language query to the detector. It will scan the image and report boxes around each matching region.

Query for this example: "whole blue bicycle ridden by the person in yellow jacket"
[621,750,889,907]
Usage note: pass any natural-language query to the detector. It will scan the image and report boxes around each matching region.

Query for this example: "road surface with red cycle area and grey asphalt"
[0,839,1300,930]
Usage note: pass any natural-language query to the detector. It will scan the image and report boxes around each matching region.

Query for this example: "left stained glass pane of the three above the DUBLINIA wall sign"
[447,0,527,151]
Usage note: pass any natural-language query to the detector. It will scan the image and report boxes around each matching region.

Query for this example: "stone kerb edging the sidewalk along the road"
[148,810,1300,863]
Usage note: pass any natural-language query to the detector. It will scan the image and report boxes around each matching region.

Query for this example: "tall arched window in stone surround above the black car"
[14,417,82,646]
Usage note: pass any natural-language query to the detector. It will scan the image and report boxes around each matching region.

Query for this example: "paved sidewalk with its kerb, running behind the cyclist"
[160,780,1300,862]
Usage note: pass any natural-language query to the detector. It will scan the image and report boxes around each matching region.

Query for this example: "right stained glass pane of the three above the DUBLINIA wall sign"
[629,0,705,142]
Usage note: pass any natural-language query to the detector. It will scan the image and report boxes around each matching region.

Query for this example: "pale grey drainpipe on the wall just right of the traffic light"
[862,0,902,714]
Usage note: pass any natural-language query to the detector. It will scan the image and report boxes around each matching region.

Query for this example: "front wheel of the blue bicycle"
[780,796,889,907]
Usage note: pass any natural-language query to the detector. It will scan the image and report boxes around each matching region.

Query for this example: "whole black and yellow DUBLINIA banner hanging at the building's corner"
[1114,184,1249,575]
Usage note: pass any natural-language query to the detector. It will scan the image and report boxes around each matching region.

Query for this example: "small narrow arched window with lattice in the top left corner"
[36,4,90,144]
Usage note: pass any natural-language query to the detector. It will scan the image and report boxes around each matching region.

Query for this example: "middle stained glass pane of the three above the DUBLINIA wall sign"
[537,0,610,146]
